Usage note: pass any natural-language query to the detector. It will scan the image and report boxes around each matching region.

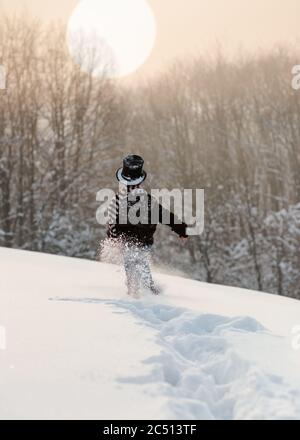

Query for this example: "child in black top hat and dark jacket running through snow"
[107,154,187,297]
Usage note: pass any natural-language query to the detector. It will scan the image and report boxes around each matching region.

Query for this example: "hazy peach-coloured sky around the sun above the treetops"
[0,0,300,79]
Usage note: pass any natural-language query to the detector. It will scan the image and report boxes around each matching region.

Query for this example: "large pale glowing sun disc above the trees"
[66,0,156,78]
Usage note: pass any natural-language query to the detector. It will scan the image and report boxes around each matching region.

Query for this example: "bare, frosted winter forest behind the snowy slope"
[0,16,300,298]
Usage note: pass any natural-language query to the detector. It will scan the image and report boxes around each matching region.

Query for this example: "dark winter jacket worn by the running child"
[107,189,187,246]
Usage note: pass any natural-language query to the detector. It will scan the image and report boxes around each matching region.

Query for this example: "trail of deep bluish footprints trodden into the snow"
[56,298,300,419]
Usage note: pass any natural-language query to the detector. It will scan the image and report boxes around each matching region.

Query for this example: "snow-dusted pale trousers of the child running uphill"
[123,243,155,295]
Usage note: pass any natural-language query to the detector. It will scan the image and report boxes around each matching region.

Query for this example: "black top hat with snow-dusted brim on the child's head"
[116,154,147,186]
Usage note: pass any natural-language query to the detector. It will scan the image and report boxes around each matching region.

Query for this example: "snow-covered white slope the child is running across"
[0,248,300,419]
